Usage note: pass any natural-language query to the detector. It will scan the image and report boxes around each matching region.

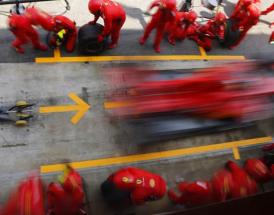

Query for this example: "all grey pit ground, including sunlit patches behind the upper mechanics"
[0,0,274,215]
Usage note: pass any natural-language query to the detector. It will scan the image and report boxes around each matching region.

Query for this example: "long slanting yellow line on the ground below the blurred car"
[40,137,272,174]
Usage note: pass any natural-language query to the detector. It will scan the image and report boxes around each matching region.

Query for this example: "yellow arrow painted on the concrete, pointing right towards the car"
[39,93,90,124]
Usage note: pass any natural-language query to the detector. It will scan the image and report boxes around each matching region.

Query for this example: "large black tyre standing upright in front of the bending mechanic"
[78,24,107,55]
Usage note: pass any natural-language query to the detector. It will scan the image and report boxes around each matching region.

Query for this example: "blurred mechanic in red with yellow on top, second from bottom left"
[47,165,86,215]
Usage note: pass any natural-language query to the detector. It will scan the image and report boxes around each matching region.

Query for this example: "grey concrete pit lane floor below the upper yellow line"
[0,62,274,214]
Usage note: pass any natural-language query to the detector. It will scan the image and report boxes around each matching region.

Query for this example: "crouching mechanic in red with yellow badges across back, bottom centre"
[101,167,166,205]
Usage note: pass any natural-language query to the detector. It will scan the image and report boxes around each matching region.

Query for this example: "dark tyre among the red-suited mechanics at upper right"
[219,19,240,48]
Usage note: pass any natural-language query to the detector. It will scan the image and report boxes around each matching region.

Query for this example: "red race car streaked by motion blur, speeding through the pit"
[106,62,274,141]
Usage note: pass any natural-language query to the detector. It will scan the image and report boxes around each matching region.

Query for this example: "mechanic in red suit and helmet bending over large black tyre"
[88,0,126,49]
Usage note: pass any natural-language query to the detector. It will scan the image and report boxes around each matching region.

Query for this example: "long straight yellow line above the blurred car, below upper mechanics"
[35,55,245,63]
